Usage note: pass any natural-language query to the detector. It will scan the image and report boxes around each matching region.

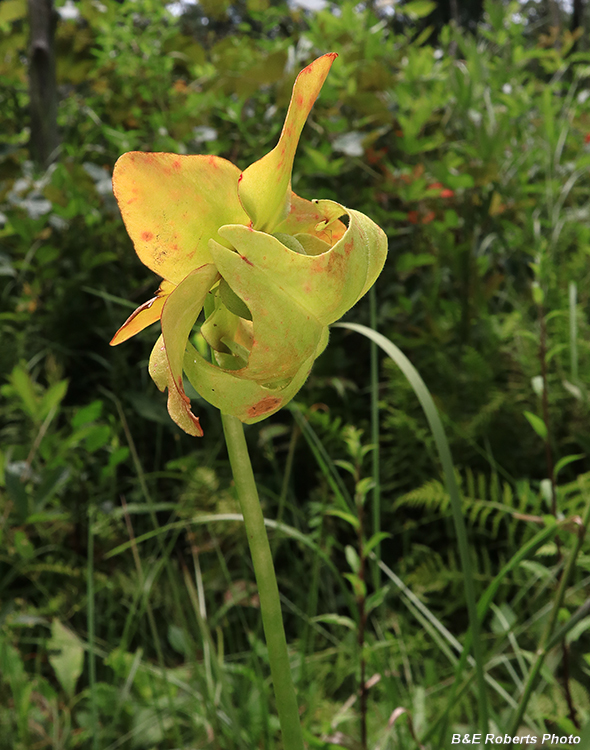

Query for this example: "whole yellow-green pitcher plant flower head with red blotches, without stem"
[111,53,387,436]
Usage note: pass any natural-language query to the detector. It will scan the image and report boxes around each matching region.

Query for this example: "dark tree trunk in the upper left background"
[28,0,59,167]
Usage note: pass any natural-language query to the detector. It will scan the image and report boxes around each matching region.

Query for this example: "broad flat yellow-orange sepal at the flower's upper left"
[113,151,250,284]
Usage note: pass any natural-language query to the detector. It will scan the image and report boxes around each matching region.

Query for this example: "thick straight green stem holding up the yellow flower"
[221,414,303,750]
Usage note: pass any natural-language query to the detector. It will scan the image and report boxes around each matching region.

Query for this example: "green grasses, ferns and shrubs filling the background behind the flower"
[0,0,590,750]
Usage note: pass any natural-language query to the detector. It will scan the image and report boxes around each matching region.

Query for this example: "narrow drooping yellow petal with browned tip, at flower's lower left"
[154,263,219,435]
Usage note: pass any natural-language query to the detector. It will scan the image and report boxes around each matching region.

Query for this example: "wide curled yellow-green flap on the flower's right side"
[215,201,387,328]
